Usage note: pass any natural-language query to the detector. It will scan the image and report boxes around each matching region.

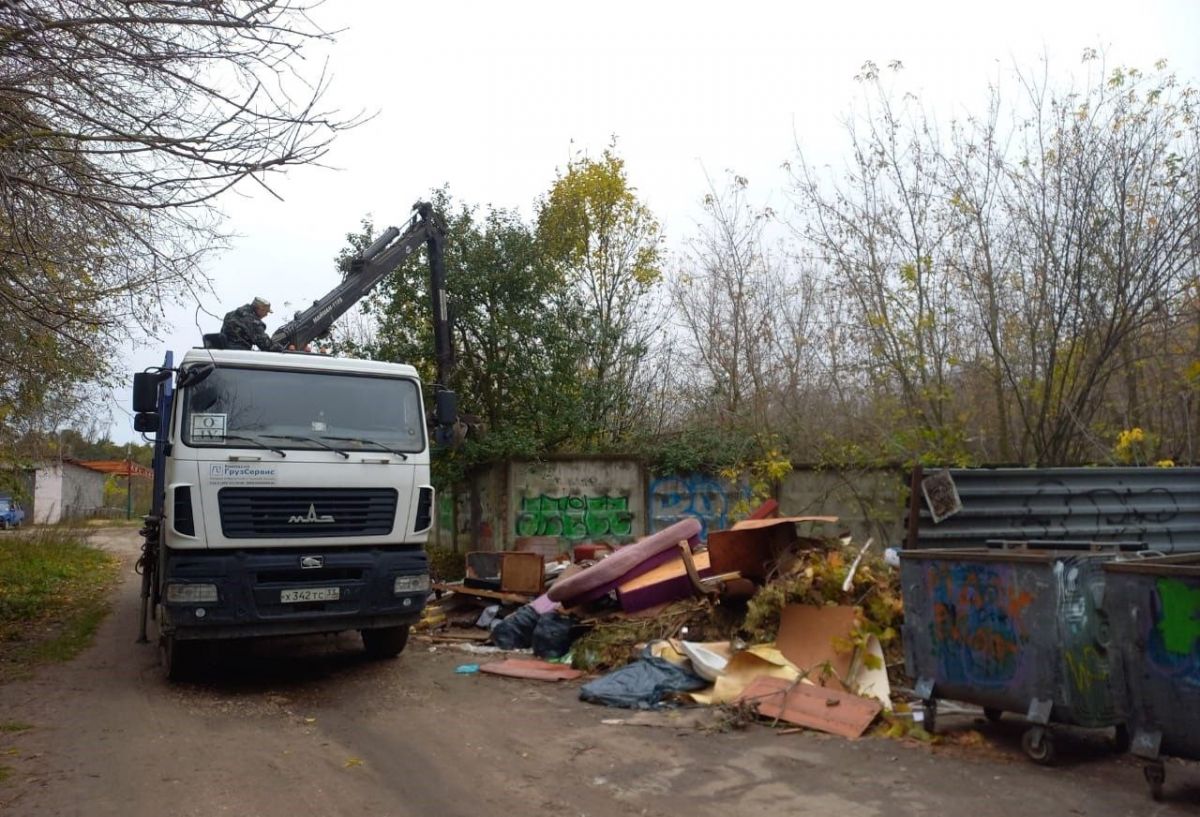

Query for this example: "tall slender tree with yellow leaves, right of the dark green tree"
[536,146,662,446]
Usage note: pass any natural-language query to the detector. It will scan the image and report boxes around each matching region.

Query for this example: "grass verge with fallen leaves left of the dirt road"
[0,529,119,683]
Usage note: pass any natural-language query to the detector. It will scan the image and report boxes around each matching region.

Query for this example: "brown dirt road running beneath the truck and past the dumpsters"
[0,529,1200,817]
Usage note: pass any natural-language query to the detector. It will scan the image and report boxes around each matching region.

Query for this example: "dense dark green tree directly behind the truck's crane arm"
[343,190,583,472]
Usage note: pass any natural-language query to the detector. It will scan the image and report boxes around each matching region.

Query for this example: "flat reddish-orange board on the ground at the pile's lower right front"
[737,677,883,739]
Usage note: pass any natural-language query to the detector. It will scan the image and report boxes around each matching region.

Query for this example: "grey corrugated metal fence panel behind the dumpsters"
[907,468,1200,553]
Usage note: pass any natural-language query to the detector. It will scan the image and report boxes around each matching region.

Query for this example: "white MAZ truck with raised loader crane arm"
[133,203,456,680]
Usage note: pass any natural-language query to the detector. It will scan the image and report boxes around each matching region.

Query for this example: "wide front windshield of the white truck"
[175,367,425,452]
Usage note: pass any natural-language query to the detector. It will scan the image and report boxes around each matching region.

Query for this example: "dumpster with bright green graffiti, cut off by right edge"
[1104,554,1200,800]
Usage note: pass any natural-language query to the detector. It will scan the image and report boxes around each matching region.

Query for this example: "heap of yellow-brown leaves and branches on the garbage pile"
[742,539,904,663]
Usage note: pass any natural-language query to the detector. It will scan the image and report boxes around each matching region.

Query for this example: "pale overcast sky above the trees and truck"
[110,0,1200,441]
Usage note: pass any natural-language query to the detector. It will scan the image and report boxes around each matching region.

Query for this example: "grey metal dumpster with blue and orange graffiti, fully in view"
[900,548,1128,763]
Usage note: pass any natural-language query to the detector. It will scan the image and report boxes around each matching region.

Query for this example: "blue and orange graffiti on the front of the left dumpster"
[925,561,1033,689]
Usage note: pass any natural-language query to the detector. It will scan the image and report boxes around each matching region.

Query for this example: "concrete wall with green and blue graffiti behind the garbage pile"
[431,457,906,552]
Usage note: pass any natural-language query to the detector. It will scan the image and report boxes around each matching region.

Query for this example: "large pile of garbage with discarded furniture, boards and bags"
[418,507,904,737]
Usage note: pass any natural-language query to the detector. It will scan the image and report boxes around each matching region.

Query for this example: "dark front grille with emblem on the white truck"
[217,488,397,539]
